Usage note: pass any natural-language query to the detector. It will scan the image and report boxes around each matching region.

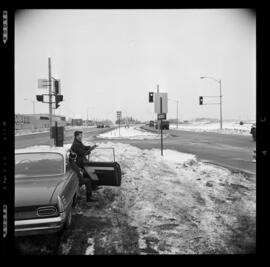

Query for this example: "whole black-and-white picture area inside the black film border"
[3,8,257,256]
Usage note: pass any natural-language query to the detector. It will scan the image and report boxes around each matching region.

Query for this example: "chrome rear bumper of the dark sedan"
[15,212,66,236]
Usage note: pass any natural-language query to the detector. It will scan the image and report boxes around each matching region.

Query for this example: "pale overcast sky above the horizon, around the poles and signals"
[15,9,256,120]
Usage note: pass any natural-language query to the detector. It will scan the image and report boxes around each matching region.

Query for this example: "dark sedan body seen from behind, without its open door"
[15,148,79,236]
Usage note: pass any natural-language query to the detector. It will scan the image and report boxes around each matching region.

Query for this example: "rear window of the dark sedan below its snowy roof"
[15,152,64,179]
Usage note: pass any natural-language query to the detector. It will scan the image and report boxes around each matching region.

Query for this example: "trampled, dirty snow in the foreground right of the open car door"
[80,142,256,254]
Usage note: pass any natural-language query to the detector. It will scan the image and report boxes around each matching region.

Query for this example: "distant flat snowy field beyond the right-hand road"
[170,120,252,135]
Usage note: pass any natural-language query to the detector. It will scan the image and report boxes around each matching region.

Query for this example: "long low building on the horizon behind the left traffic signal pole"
[15,114,66,130]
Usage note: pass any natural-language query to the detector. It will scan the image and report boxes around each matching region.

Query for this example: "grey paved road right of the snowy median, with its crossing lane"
[96,126,256,177]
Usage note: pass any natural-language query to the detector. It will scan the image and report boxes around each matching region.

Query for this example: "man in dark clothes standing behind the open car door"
[70,131,97,204]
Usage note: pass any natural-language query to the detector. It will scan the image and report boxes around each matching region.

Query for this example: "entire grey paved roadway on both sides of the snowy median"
[15,127,256,174]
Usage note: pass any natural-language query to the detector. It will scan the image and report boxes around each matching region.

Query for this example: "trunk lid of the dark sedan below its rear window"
[15,176,64,207]
